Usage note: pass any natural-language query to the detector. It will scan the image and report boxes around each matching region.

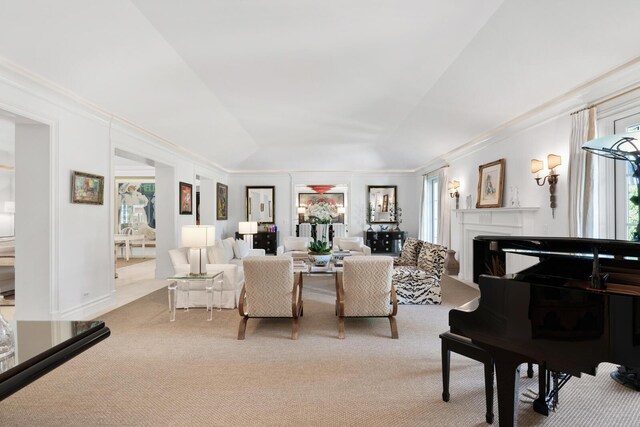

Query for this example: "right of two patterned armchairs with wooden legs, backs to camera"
[336,256,398,338]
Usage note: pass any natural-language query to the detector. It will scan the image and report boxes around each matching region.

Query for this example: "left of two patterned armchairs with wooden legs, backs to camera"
[238,256,302,340]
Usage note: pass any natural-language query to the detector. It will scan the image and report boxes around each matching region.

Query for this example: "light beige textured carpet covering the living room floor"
[0,279,640,427]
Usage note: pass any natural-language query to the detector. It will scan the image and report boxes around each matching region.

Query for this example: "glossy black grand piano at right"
[449,236,640,426]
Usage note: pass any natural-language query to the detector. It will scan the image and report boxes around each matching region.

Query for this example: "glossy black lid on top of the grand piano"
[474,236,640,261]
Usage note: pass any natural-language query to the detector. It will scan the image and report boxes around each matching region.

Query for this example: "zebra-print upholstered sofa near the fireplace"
[392,237,447,304]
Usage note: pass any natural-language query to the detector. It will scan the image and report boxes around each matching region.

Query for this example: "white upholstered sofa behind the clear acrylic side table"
[169,237,265,308]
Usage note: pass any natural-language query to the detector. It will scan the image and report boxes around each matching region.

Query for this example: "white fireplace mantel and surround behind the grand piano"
[451,207,539,280]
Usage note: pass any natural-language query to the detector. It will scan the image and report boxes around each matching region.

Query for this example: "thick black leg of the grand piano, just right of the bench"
[491,348,522,427]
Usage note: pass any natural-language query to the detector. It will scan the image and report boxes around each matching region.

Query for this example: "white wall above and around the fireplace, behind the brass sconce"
[442,115,571,260]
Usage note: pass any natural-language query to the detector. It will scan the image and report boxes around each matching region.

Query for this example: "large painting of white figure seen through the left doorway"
[114,176,156,233]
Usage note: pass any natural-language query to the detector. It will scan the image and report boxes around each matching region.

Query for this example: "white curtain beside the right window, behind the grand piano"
[567,107,596,237]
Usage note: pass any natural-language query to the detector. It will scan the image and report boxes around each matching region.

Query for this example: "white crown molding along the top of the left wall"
[0,56,228,173]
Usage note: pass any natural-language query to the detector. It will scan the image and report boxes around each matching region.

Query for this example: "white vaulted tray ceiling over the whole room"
[0,0,640,171]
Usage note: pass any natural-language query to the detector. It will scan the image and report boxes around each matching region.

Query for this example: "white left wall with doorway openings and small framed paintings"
[0,61,226,319]
